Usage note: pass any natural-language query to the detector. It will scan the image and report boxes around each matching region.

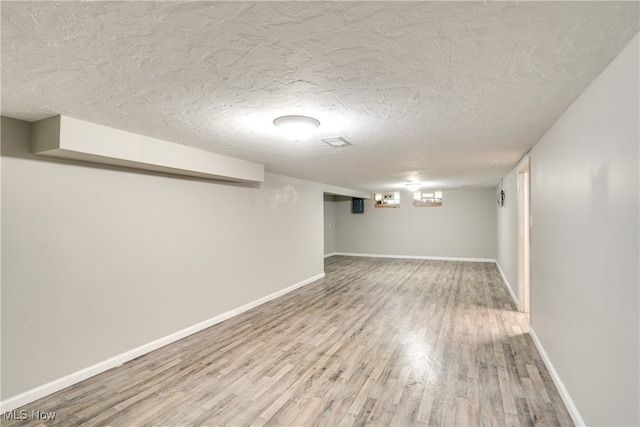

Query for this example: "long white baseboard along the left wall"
[0,273,325,413]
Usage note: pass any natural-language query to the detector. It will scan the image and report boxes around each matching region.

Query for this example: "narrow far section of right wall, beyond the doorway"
[496,167,519,298]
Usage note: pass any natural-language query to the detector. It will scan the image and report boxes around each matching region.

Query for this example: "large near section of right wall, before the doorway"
[516,36,640,425]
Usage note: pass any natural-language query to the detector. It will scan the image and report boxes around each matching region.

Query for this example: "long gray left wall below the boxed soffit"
[2,118,323,399]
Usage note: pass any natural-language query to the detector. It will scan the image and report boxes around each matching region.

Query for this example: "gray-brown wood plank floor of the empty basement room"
[2,256,573,426]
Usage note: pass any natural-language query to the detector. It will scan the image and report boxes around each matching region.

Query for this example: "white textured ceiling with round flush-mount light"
[1,1,640,191]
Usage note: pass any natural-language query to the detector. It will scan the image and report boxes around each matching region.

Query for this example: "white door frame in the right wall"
[518,156,531,313]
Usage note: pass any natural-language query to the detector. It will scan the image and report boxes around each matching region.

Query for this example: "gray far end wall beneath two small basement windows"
[336,188,496,259]
